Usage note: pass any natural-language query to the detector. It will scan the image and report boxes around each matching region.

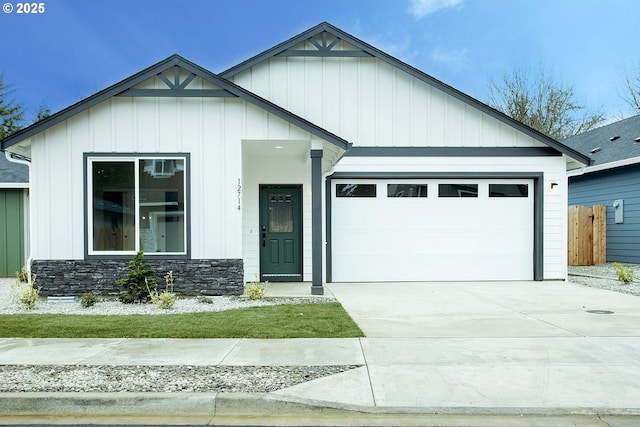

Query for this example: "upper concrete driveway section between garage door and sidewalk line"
[327,281,640,338]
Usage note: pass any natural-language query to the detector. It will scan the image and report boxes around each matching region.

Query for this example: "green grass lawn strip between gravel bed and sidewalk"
[0,303,364,338]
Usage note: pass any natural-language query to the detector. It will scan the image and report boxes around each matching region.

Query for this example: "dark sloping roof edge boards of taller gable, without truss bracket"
[220,22,590,165]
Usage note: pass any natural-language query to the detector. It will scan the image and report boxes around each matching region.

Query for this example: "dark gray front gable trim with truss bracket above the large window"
[0,55,351,150]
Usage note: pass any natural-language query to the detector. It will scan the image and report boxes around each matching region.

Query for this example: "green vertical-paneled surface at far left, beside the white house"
[0,189,25,277]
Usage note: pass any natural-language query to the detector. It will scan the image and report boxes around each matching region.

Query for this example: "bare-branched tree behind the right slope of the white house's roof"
[488,67,604,141]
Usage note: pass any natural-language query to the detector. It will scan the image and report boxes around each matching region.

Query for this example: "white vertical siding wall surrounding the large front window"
[26,73,320,260]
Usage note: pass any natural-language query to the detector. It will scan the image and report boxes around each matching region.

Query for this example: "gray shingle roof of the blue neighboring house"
[563,115,640,170]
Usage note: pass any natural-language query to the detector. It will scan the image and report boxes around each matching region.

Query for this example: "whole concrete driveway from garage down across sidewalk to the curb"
[320,281,640,412]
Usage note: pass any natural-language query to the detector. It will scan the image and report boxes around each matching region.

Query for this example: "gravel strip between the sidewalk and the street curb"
[0,365,359,393]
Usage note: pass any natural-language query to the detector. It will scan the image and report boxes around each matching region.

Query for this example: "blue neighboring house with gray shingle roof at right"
[563,115,640,263]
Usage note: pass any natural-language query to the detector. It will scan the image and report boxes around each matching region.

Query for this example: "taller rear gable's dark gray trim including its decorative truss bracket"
[220,22,590,165]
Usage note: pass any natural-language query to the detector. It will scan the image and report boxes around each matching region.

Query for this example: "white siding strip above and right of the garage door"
[335,156,567,280]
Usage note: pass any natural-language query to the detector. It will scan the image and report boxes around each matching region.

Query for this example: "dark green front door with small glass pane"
[260,185,302,282]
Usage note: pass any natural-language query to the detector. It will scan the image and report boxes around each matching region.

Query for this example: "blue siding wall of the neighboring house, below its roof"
[569,165,640,263]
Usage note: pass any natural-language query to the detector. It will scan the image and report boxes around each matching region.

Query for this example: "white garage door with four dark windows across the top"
[331,179,533,282]
